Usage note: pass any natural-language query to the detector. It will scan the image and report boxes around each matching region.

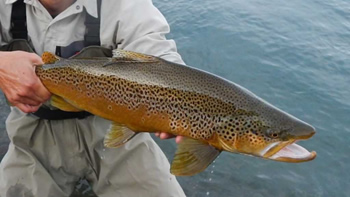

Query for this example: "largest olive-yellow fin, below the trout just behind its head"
[170,138,221,176]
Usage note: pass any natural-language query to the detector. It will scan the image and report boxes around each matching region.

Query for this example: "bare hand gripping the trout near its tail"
[0,51,51,113]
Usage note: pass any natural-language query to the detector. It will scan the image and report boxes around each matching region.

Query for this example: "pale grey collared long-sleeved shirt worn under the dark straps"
[0,0,184,64]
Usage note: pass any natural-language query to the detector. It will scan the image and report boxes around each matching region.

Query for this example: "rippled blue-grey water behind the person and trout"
[0,0,350,197]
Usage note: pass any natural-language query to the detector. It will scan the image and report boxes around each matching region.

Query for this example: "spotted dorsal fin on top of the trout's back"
[112,49,158,62]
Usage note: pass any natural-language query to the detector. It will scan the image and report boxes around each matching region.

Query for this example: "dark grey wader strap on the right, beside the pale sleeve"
[84,0,102,47]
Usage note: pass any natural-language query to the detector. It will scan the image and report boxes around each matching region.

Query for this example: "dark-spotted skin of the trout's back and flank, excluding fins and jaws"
[37,52,304,152]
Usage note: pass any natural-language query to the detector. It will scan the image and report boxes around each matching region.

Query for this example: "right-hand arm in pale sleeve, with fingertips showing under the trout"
[105,0,184,143]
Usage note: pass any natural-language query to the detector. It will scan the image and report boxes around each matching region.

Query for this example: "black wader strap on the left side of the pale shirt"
[10,0,28,40]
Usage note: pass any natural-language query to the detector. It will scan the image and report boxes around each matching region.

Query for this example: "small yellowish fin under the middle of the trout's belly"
[104,122,137,148]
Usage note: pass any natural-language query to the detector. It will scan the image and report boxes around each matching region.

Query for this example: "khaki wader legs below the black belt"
[0,108,184,197]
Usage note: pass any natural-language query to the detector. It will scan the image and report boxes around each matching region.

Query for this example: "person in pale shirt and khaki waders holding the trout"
[0,0,185,197]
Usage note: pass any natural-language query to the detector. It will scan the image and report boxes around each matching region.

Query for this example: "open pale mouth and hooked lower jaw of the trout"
[262,140,316,163]
